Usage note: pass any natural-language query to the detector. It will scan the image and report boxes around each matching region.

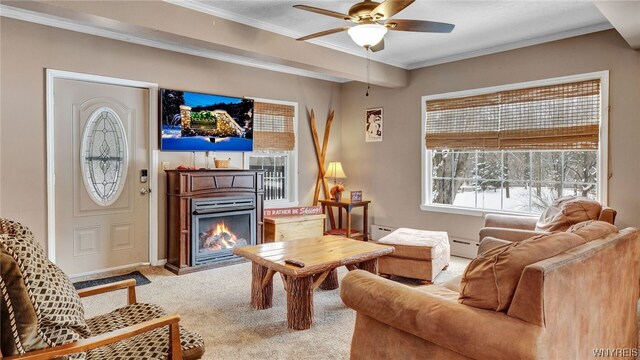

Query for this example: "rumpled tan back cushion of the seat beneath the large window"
[536,196,602,232]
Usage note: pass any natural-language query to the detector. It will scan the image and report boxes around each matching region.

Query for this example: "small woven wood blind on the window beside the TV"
[253,101,296,151]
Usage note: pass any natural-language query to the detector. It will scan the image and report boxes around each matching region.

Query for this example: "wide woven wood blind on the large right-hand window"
[426,80,600,150]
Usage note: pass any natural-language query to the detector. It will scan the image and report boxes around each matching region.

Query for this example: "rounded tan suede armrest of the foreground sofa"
[340,270,543,359]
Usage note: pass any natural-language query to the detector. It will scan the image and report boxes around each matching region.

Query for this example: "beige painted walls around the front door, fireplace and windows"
[0,18,640,258]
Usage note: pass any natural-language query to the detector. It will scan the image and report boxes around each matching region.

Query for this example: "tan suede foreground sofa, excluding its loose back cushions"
[340,228,640,360]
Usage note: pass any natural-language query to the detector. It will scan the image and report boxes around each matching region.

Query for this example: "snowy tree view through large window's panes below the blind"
[431,150,598,213]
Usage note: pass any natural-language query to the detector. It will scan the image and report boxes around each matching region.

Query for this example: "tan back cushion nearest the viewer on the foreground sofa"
[458,232,586,312]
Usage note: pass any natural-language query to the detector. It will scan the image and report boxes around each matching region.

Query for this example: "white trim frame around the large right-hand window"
[420,70,610,216]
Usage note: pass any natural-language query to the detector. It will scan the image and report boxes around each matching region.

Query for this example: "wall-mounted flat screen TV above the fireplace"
[160,89,253,151]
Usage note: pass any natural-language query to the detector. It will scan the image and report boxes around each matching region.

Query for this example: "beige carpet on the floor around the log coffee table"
[83,257,469,360]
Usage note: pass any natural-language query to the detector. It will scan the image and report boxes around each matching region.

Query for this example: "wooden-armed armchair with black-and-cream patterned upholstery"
[0,218,204,360]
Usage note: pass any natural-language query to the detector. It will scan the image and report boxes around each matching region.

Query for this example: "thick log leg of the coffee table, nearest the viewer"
[287,276,313,330]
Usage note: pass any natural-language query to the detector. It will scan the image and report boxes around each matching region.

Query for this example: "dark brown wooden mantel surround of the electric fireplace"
[165,169,264,275]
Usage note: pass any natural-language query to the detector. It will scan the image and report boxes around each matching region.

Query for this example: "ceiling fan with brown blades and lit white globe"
[293,0,455,51]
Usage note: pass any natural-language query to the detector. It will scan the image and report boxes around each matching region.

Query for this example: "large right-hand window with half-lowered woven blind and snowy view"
[422,73,607,214]
